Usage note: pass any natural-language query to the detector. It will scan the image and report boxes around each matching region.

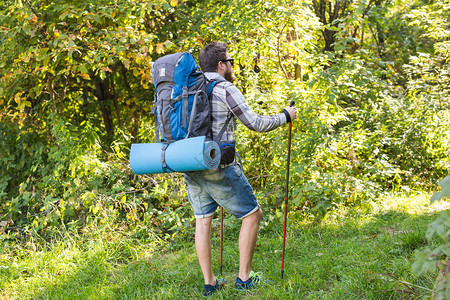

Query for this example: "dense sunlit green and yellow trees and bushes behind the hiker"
[0,0,450,298]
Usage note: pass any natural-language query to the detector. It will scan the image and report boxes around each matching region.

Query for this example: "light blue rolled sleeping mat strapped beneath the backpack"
[130,136,220,174]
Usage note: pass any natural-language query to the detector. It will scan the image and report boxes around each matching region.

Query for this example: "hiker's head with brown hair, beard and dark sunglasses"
[199,42,233,81]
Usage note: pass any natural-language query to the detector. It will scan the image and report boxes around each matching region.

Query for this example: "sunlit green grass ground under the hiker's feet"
[0,194,447,299]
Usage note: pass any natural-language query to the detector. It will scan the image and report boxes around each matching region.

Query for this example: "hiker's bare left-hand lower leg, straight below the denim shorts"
[195,216,216,285]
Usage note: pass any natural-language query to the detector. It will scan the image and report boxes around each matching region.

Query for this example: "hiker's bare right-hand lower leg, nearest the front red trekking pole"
[239,208,262,281]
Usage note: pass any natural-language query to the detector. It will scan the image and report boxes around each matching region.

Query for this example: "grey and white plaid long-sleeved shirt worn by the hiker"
[205,72,287,142]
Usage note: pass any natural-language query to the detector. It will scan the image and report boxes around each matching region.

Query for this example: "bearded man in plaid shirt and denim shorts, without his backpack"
[185,42,297,295]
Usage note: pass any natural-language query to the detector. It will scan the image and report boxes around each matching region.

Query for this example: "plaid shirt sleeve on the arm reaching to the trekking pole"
[225,84,287,132]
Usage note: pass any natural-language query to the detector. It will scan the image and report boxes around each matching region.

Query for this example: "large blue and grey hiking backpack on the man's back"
[152,52,223,144]
